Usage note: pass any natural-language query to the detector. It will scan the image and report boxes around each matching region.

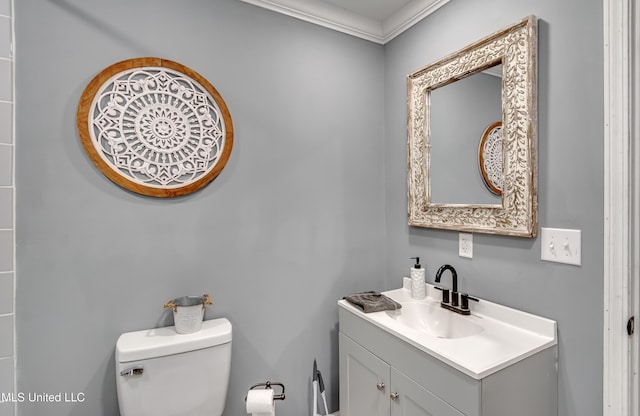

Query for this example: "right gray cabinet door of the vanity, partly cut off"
[390,368,464,416]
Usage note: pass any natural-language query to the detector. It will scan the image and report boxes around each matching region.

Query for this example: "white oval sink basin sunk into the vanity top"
[387,302,482,338]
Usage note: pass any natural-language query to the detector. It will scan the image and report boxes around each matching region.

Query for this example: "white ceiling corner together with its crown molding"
[235,0,449,44]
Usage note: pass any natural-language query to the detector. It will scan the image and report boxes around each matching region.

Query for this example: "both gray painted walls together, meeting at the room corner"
[15,0,603,416]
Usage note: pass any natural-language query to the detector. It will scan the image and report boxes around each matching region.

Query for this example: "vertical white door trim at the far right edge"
[603,0,633,416]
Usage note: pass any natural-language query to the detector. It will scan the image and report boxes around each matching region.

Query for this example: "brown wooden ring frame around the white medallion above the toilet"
[76,57,233,198]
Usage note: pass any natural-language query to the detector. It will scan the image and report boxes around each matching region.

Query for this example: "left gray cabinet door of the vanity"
[339,333,391,416]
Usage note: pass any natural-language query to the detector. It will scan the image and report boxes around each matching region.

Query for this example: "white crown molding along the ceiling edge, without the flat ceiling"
[241,0,449,45]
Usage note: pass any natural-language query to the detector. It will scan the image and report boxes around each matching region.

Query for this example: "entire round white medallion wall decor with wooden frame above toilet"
[76,58,233,198]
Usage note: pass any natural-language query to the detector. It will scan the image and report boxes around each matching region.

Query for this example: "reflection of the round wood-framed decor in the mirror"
[478,121,504,195]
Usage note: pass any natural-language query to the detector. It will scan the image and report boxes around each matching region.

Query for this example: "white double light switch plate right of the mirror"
[540,228,582,266]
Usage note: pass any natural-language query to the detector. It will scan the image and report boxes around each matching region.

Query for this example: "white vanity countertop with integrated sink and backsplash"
[338,278,558,380]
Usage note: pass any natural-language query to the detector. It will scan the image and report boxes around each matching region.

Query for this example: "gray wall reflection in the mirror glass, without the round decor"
[430,63,502,205]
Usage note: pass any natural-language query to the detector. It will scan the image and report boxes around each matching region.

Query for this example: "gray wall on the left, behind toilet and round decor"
[15,0,385,416]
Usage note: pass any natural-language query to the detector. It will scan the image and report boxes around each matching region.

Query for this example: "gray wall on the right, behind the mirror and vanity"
[385,0,604,416]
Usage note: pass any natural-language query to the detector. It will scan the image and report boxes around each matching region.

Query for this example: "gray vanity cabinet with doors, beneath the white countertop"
[339,307,557,416]
